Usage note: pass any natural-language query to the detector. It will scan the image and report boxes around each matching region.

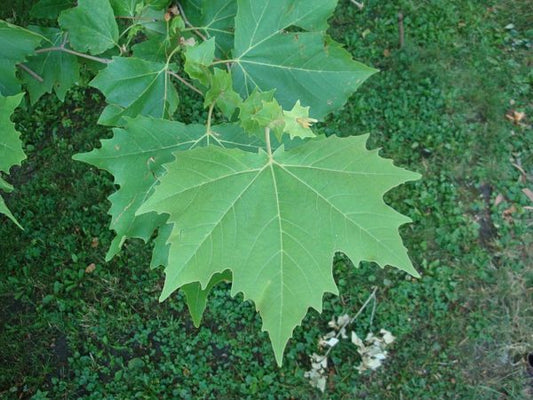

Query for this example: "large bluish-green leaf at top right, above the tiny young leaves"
[232,0,375,118]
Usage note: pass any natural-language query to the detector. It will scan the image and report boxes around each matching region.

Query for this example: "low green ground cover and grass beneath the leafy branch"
[0,2,531,399]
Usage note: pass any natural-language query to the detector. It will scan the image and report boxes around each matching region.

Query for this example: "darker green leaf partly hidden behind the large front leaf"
[74,117,260,260]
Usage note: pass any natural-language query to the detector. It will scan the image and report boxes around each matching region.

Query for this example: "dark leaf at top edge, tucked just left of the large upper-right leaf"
[181,0,237,57]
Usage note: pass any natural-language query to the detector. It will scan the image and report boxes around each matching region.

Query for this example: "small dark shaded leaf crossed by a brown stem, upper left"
[21,28,80,104]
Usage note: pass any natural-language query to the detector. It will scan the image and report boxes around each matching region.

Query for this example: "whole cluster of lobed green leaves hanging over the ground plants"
[0,0,418,365]
